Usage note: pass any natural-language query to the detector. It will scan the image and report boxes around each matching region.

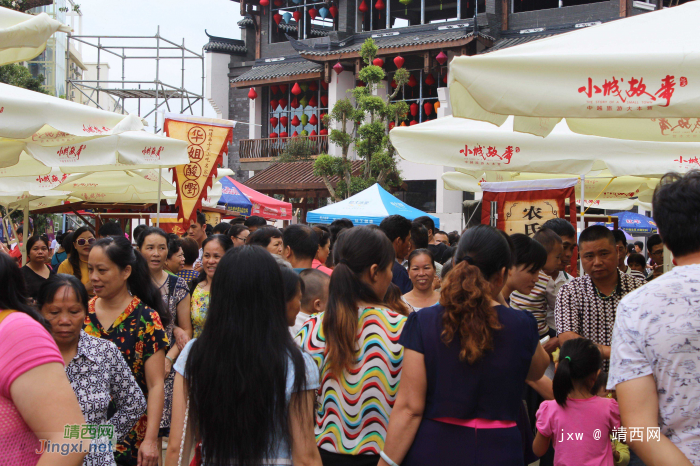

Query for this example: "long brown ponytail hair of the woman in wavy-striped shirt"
[322,226,396,379]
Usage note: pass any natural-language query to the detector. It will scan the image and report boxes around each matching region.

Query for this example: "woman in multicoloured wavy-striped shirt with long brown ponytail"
[296,227,406,466]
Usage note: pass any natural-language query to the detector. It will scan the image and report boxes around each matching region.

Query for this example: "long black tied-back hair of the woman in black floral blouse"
[92,236,171,328]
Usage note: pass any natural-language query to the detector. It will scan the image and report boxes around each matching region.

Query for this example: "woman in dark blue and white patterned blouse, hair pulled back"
[37,274,146,466]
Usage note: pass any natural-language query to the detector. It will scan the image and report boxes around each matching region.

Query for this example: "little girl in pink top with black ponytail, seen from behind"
[532,338,620,466]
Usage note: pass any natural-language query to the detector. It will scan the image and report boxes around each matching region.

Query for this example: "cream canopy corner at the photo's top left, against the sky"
[0,7,71,65]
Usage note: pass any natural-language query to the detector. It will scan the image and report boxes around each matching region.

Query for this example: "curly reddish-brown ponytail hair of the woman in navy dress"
[440,225,513,364]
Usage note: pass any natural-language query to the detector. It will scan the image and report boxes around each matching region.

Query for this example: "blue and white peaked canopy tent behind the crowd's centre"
[306,184,440,229]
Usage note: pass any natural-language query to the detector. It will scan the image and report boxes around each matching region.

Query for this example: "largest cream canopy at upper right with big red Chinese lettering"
[449,2,700,142]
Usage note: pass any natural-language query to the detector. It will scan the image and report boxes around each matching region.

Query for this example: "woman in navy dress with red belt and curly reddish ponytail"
[379,225,549,466]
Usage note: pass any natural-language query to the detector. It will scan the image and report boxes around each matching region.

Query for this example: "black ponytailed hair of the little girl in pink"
[552,338,603,407]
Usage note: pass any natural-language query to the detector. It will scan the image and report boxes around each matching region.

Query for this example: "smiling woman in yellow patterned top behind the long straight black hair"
[190,235,233,338]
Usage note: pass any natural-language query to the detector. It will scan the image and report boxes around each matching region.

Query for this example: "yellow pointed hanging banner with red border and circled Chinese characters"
[164,116,233,226]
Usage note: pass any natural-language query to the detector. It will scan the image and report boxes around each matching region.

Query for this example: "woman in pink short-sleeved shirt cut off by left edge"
[0,253,87,466]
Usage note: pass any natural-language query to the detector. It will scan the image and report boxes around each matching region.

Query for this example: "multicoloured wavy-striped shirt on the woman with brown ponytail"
[295,308,406,455]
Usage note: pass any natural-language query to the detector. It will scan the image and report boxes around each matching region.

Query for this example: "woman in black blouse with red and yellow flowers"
[84,236,170,466]
